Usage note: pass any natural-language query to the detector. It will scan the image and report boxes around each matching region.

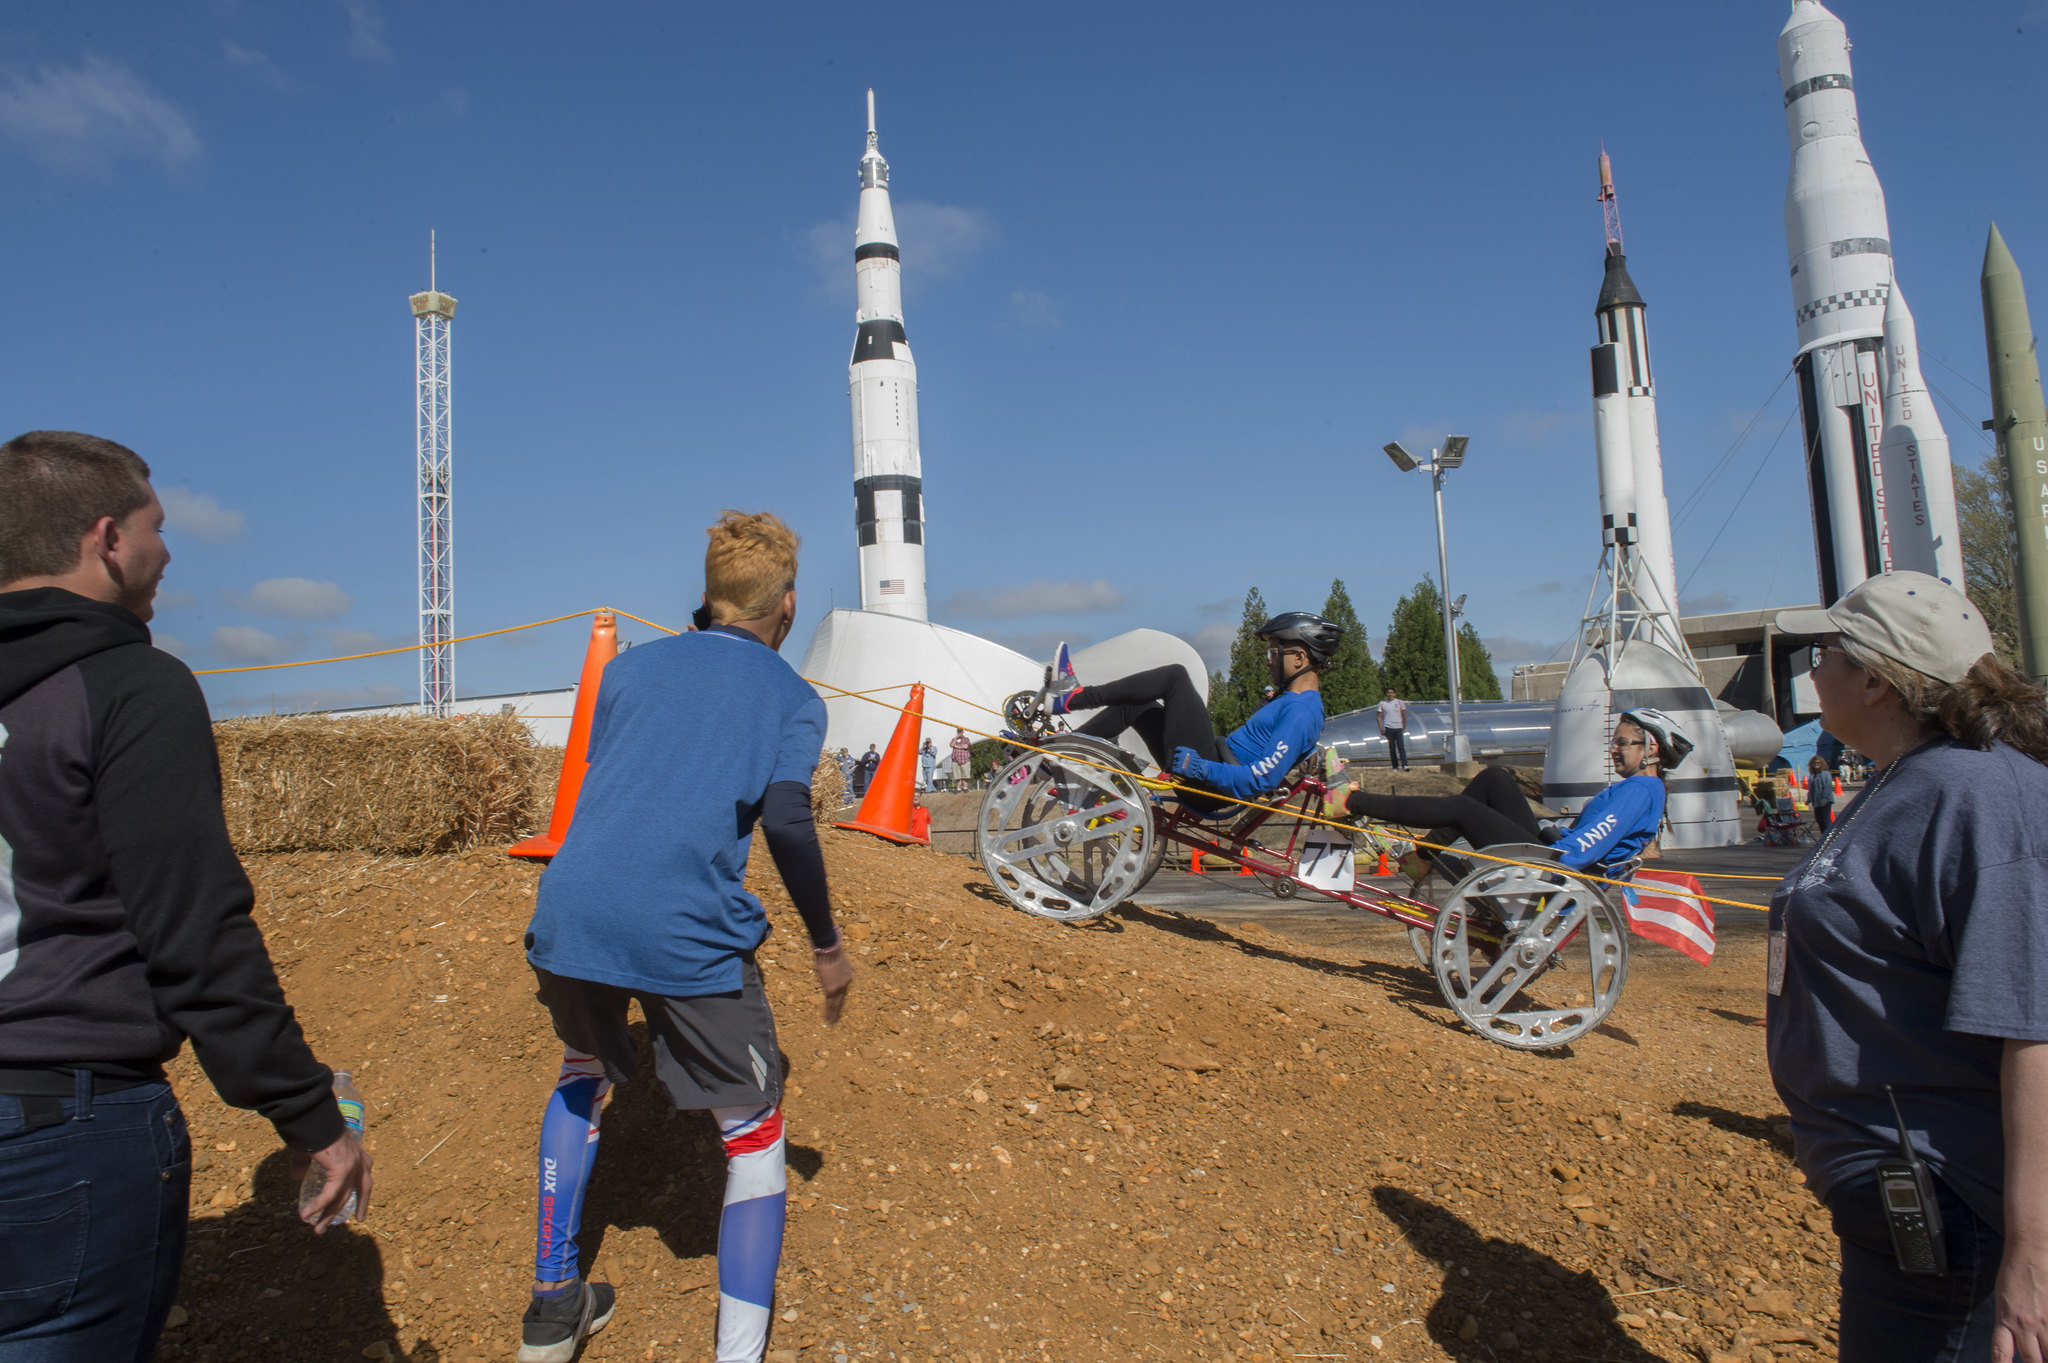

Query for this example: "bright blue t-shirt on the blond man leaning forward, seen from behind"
[526,626,825,997]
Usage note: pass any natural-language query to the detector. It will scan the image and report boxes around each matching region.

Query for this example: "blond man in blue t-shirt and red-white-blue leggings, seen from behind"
[518,512,854,1363]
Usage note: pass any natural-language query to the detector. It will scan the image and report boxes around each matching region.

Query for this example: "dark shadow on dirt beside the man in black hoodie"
[156,1150,411,1363]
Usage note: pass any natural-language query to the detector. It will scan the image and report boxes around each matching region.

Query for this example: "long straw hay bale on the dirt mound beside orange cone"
[213,714,537,855]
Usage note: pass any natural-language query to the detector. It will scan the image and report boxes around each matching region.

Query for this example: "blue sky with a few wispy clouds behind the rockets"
[0,0,2048,712]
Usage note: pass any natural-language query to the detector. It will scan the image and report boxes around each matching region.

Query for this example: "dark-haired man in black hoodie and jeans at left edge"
[0,432,371,1363]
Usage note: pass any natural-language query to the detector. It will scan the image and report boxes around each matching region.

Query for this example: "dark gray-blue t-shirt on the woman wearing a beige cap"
[1763,737,2048,1232]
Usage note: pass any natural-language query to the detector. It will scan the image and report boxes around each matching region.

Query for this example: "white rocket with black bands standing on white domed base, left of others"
[848,90,926,620]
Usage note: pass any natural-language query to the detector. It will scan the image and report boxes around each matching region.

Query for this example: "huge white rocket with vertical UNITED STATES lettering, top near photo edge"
[1778,0,1964,602]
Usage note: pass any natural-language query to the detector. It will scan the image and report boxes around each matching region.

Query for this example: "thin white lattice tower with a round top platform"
[412,233,455,718]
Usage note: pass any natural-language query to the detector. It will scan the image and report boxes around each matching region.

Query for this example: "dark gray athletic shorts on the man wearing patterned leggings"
[532,956,782,1111]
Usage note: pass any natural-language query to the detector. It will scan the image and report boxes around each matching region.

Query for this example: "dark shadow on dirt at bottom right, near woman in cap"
[1372,1185,1690,1363]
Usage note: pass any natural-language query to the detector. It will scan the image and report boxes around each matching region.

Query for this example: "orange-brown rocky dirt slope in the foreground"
[160,833,1835,1363]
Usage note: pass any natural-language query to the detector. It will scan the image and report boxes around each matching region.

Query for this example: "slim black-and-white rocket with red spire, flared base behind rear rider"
[1542,151,1744,847]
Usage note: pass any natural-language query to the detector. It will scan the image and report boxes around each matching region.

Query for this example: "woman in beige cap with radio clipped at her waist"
[1767,573,2048,1363]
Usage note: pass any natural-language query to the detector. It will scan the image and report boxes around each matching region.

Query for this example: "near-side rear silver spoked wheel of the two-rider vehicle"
[1430,866,1628,1050]
